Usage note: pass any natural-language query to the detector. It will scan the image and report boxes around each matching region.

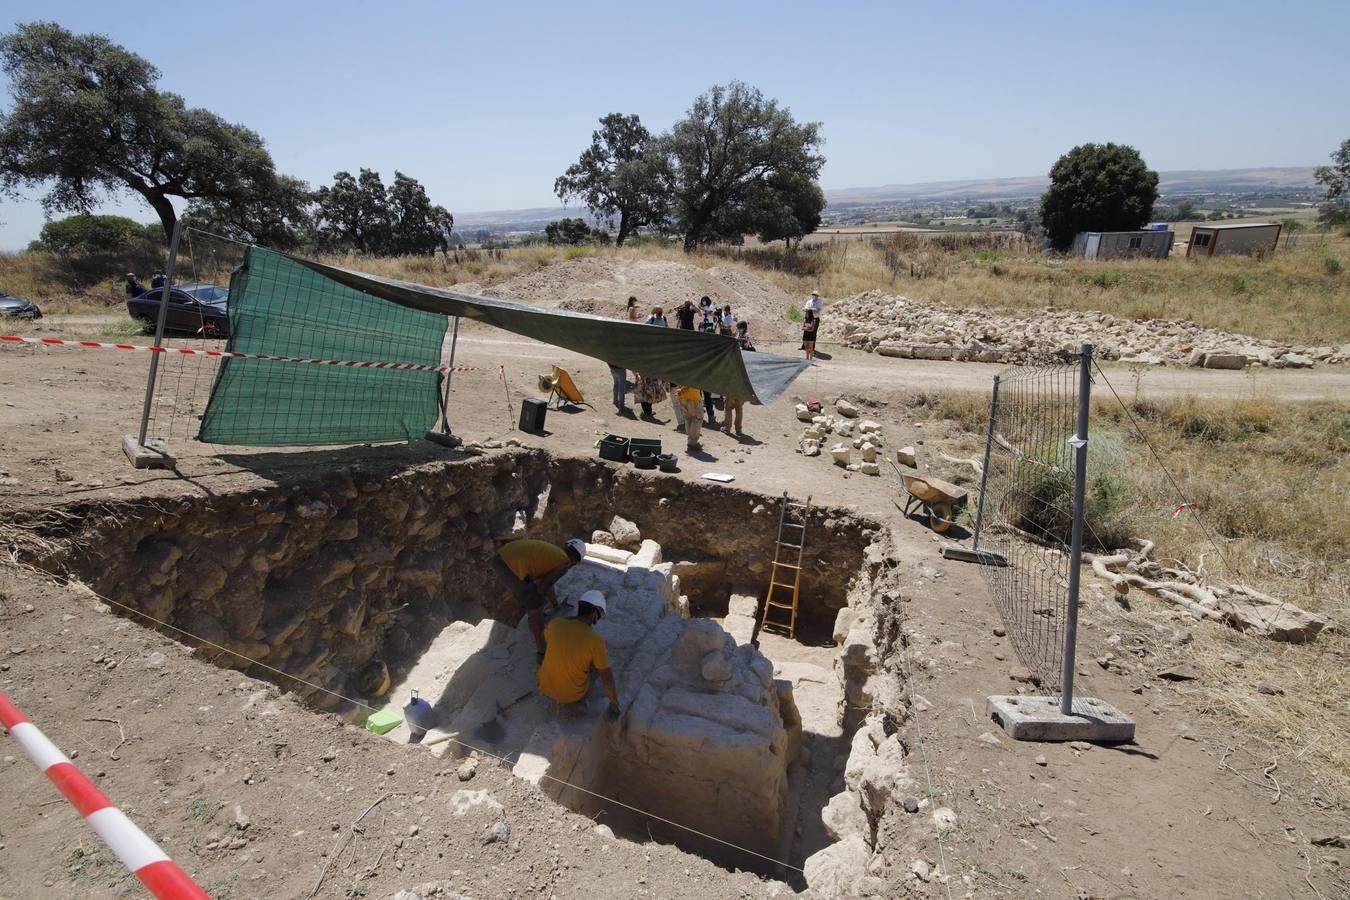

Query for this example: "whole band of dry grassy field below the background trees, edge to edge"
[0,225,1350,344]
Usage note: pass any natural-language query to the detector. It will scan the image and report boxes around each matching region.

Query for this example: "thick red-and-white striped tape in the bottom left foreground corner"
[0,691,209,900]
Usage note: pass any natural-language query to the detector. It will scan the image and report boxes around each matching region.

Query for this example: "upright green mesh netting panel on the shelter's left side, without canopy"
[197,247,448,447]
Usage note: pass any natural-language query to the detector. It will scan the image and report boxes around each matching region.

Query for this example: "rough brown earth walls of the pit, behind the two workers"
[35,449,876,708]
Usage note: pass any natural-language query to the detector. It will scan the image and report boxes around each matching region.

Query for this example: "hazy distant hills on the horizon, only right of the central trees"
[825,166,1315,208]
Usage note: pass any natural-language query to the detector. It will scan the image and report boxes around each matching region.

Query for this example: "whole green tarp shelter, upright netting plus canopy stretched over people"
[198,247,810,447]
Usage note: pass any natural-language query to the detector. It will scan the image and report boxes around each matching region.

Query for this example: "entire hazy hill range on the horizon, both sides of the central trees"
[455,166,1315,232]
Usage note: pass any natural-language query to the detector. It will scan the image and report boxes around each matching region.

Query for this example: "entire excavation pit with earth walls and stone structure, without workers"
[50,449,876,877]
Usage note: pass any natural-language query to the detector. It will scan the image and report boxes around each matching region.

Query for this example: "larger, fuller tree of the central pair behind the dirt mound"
[662,81,825,250]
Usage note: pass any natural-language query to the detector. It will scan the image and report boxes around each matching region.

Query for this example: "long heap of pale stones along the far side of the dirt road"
[822,290,1350,368]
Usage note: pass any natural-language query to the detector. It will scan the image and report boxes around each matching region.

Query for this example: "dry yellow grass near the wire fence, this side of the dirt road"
[915,386,1350,806]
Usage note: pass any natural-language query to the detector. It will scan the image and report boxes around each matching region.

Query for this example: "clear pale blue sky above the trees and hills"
[0,0,1350,248]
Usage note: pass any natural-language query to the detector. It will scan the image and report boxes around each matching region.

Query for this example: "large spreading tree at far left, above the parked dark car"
[0,22,294,242]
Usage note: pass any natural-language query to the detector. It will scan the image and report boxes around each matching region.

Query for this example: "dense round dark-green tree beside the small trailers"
[1041,143,1158,250]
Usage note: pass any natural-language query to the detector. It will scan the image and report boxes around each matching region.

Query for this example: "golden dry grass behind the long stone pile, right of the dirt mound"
[707,235,1350,344]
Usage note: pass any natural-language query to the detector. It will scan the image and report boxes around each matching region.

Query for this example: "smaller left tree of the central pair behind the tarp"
[554,112,666,247]
